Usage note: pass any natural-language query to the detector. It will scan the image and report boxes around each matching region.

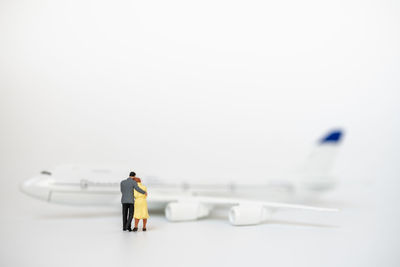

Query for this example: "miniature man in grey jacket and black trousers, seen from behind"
[121,172,147,232]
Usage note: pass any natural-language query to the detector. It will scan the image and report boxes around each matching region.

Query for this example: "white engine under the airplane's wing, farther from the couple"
[229,205,271,226]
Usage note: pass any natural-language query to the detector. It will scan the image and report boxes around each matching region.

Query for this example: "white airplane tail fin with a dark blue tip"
[300,129,344,191]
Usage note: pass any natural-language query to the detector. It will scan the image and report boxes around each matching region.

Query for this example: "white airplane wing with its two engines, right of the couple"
[148,194,339,225]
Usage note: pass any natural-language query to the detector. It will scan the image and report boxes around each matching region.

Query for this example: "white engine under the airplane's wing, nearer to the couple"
[165,202,210,222]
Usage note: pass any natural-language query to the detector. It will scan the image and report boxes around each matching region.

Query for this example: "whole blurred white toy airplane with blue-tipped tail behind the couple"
[20,130,343,225]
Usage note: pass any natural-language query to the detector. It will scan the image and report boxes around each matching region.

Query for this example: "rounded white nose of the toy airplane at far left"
[20,175,51,201]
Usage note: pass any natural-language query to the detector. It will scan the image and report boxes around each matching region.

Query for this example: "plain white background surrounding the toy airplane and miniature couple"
[0,0,400,266]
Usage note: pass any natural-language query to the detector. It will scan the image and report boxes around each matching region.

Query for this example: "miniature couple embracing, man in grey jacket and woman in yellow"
[121,172,149,232]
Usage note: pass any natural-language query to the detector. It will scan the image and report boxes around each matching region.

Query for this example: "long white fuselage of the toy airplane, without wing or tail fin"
[21,174,322,209]
